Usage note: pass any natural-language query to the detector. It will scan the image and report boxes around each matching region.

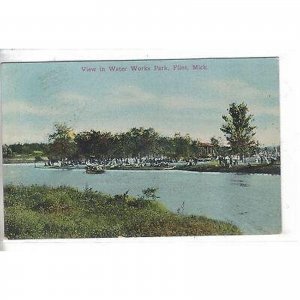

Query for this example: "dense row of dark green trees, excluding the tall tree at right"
[3,124,213,160]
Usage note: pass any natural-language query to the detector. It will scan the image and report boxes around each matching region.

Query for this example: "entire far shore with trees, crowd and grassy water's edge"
[2,103,280,174]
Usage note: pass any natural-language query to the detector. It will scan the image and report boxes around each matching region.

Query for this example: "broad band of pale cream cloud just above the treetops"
[3,80,279,142]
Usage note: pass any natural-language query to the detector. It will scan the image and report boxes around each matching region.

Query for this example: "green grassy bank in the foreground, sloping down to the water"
[4,185,240,239]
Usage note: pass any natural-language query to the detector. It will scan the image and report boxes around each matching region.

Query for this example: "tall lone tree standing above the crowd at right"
[220,102,257,156]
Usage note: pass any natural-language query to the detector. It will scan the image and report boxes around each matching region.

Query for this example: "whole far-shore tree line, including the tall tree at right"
[2,103,258,160]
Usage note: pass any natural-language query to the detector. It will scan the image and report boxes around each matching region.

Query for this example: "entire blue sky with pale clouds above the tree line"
[1,58,280,146]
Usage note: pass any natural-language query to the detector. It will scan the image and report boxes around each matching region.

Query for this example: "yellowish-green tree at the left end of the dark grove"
[49,123,76,160]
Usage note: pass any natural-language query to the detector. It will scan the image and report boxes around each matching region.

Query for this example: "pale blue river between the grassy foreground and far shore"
[3,164,281,234]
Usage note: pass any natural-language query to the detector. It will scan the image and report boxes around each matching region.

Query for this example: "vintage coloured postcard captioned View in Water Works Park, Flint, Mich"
[1,57,282,240]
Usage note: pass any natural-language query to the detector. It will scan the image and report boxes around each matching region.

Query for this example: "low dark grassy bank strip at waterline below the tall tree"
[176,164,280,175]
